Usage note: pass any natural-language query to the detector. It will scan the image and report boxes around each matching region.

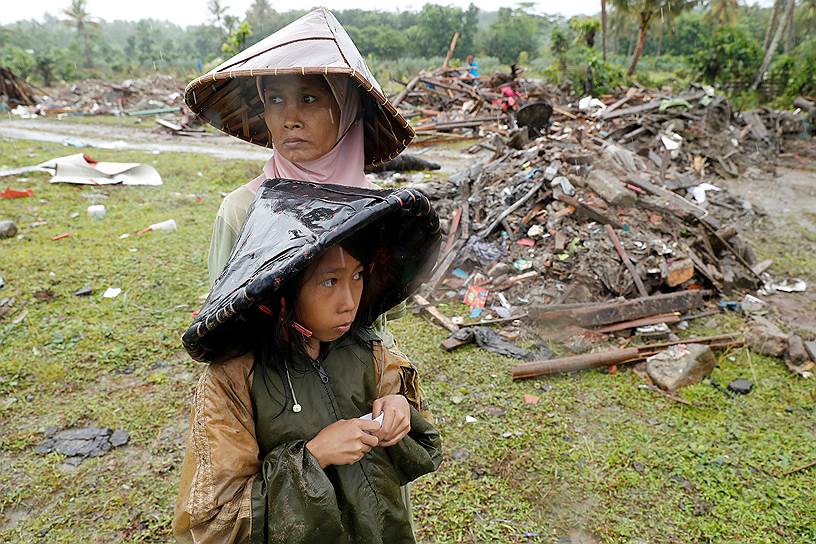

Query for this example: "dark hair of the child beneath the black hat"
[252,236,373,417]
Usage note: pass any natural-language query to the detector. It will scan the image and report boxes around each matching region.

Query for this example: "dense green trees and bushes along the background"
[0,0,816,102]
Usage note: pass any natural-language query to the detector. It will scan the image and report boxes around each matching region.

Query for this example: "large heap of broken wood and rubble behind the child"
[380,77,812,382]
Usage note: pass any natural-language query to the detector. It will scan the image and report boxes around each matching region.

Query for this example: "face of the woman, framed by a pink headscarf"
[263,74,340,163]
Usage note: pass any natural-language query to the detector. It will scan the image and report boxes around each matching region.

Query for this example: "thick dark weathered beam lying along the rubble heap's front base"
[527,289,713,328]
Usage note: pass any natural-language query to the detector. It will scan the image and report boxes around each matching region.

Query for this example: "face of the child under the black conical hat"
[295,246,363,342]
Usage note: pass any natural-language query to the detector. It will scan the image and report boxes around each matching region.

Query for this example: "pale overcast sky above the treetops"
[0,0,773,26]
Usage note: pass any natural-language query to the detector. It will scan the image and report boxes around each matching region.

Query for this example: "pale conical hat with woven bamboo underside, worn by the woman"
[184,8,414,166]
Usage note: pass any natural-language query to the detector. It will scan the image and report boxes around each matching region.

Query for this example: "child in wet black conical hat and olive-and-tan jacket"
[173,179,441,543]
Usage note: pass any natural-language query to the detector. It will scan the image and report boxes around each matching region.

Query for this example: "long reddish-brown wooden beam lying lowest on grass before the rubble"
[512,334,745,380]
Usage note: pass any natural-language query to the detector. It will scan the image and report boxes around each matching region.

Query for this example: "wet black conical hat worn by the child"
[182,179,441,362]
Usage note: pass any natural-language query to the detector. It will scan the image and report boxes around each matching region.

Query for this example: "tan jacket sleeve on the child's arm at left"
[173,355,261,544]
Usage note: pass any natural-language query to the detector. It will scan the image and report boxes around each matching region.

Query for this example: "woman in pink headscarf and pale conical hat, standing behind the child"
[185,8,414,283]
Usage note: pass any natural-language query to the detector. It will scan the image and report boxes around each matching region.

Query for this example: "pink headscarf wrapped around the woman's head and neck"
[246,76,371,193]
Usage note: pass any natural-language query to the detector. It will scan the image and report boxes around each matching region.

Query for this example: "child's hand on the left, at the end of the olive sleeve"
[306,419,379,468]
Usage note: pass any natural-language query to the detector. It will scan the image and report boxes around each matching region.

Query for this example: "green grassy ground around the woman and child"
[0,140,816,543]
